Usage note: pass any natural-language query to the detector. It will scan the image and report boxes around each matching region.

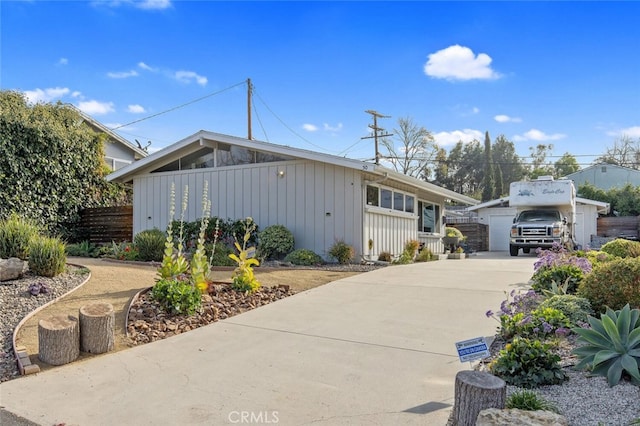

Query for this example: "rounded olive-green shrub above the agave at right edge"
[578,258,640,314]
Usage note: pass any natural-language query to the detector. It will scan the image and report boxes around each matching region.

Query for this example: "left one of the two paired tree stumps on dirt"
[38,315,80,365]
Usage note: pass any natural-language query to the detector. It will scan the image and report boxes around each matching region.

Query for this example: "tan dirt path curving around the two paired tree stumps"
[16,258,360,370]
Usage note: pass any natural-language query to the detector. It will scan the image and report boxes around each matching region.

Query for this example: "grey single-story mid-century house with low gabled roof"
[107,131,478,260]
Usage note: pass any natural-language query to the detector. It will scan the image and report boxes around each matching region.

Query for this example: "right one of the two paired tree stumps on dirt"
[80,303,115,354]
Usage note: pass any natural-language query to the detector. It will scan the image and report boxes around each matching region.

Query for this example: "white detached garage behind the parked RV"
[467,196,609,251]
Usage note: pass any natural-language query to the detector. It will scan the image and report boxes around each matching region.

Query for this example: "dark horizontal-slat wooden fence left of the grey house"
[79,206,133,244]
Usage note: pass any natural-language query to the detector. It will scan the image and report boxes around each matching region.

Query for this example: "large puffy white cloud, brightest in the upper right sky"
[424,44,501,81]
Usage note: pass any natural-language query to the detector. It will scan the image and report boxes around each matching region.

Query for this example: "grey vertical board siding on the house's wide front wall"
[133,161,363,258]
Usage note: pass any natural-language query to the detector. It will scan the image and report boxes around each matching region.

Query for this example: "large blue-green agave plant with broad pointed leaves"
[573,304,640,387]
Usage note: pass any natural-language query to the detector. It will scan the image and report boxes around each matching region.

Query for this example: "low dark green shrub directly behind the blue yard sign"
[489,337,566,388]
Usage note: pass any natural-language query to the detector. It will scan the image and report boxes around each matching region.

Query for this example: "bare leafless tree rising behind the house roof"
[382,118,438,180]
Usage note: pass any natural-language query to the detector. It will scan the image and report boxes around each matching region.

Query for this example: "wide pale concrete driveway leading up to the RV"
[0,253,535,426]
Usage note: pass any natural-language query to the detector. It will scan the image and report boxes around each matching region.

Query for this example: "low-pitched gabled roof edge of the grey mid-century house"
[107,130,478,205]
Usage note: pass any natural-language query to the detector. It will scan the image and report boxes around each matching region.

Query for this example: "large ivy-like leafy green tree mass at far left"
[0,91,126,238]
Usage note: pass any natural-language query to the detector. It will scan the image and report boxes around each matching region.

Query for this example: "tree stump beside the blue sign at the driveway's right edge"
[453,371,507,426]
